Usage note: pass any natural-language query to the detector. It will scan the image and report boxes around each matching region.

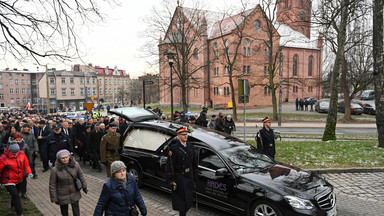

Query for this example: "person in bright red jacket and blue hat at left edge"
[0,144,33,216]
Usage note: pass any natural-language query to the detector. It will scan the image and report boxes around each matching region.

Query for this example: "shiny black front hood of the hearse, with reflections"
[241,164,330,197]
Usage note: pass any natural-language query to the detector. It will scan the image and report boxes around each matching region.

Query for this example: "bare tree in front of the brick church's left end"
[145,0,207,112]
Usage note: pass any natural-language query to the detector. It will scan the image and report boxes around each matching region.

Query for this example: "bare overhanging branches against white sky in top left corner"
[0,0,113,62]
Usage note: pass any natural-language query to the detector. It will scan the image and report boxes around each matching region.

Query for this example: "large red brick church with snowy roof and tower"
[159,0,322,108]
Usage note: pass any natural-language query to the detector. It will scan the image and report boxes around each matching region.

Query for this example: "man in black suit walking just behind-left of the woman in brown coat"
[35,120,52,172]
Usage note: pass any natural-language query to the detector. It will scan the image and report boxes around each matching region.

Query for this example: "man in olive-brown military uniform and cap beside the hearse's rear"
[100,123,121,177]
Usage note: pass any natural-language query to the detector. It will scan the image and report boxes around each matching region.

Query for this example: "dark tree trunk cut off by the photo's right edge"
[373,0,384,148]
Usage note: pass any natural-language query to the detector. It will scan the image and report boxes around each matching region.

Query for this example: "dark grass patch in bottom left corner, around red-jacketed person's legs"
[0,187,43,216]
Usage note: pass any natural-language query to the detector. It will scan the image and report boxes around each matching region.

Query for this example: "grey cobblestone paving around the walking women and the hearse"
[27,159,384,216]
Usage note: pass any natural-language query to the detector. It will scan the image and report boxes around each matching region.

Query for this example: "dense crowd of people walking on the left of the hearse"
[0,111,146,216]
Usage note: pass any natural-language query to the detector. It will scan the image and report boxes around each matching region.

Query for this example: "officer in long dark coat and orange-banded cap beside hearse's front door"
[165,127,197,216]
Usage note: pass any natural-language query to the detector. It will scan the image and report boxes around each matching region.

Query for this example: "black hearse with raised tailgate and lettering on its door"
[111,107,337,216]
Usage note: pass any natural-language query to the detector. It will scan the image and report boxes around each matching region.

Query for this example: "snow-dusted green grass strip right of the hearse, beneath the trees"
[249,140,384,169]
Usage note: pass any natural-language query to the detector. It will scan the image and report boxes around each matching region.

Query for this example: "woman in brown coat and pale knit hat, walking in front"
[49,149,88,216]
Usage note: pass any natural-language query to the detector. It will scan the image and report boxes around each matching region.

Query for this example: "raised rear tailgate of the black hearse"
[109,107,159,122]
